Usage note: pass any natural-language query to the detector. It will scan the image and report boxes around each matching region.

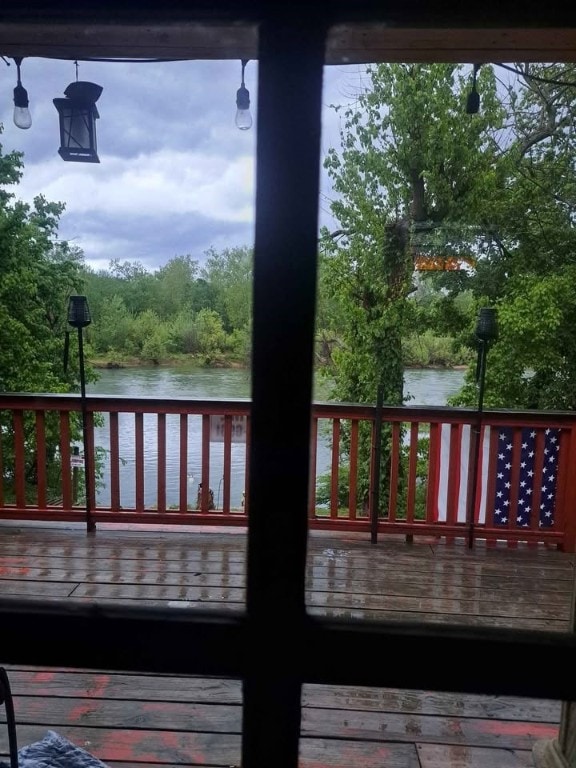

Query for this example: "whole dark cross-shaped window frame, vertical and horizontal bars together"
[0,6,576,768]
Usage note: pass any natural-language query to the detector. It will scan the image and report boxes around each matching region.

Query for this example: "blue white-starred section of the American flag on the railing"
[493,427,560,528]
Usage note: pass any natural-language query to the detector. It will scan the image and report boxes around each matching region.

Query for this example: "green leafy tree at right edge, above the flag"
[452,64,576,410]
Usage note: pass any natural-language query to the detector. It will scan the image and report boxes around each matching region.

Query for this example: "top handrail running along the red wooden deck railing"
[0,392,576,428]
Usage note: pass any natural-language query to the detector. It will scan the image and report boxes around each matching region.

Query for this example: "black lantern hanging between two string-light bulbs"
[54,80,103,163]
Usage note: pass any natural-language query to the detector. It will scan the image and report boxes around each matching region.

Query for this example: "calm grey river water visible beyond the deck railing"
[87,368,464,507]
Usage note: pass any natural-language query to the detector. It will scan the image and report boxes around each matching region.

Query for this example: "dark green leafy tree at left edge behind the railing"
[0,130,92,504]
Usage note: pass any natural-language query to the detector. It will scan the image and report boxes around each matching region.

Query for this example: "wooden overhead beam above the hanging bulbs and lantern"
[0,20,576,65]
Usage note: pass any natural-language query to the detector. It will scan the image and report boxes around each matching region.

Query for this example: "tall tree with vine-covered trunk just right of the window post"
[321,64,503,510]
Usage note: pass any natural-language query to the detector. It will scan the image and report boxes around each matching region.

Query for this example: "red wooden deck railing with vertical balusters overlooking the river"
[0,394,576,552]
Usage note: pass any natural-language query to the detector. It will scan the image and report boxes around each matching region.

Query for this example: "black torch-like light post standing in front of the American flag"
[467,307,498,549]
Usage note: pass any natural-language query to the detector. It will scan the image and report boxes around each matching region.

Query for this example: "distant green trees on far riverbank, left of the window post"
[85,248,252,363]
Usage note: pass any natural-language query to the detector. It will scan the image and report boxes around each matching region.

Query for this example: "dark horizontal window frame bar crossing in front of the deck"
[0,598,576,700]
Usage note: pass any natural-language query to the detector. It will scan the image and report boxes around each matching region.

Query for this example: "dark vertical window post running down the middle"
[242,13,325,768]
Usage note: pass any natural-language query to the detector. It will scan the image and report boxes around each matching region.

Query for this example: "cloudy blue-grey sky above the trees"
[0,58,361,270]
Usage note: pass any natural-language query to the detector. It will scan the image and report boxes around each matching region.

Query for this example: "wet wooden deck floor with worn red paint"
[0,526,574,768]
